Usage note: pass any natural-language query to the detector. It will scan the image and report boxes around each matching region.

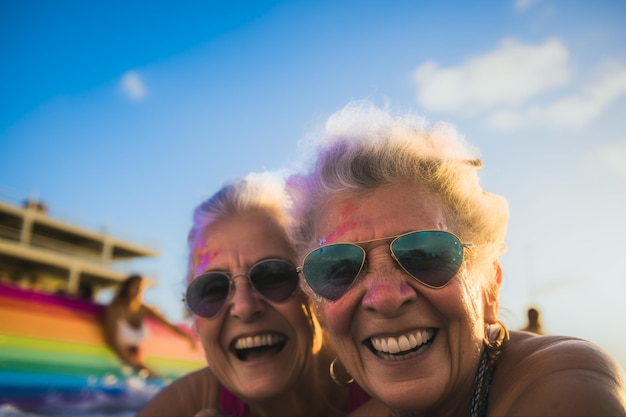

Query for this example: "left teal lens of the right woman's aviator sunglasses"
[302,243,365,301]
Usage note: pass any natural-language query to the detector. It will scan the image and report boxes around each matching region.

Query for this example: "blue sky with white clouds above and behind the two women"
[0,0,626,366]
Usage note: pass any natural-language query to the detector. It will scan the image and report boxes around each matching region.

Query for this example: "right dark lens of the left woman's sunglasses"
[250,260,298,302]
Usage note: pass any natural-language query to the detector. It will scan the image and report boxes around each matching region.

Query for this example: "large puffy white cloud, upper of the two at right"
[413,39,571,111]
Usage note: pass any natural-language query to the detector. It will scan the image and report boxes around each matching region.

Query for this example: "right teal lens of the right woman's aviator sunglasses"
[391,230,463,288]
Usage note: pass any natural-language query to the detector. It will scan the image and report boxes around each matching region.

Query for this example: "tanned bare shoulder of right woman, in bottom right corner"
[490,332,626,416]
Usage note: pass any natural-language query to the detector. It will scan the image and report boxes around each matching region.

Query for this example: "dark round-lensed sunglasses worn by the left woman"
[183,259,298,319]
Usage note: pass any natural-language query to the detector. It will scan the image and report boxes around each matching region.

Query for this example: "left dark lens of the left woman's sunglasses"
[186,273,230,318]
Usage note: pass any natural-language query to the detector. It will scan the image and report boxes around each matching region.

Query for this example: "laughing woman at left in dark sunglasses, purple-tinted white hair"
[137,173,369,417]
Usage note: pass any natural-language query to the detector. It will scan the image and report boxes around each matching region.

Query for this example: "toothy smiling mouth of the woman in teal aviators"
[365,329,437,361]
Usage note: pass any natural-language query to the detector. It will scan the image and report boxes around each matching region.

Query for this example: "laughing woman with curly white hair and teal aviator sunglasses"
[287,102,626,416]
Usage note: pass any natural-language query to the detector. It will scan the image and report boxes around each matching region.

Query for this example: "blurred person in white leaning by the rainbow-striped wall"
[103,275,196,377]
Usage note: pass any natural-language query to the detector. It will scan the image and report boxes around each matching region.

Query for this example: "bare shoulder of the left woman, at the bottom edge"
[136,367,220,417]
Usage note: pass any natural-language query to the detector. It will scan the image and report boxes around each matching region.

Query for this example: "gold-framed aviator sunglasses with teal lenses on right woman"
[297,230,472,301]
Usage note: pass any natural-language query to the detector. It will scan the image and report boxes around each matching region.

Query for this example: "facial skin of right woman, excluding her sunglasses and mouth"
[308,184,496,415]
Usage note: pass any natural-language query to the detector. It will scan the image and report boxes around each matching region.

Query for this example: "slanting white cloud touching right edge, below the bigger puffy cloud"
[487,63,626,130]
